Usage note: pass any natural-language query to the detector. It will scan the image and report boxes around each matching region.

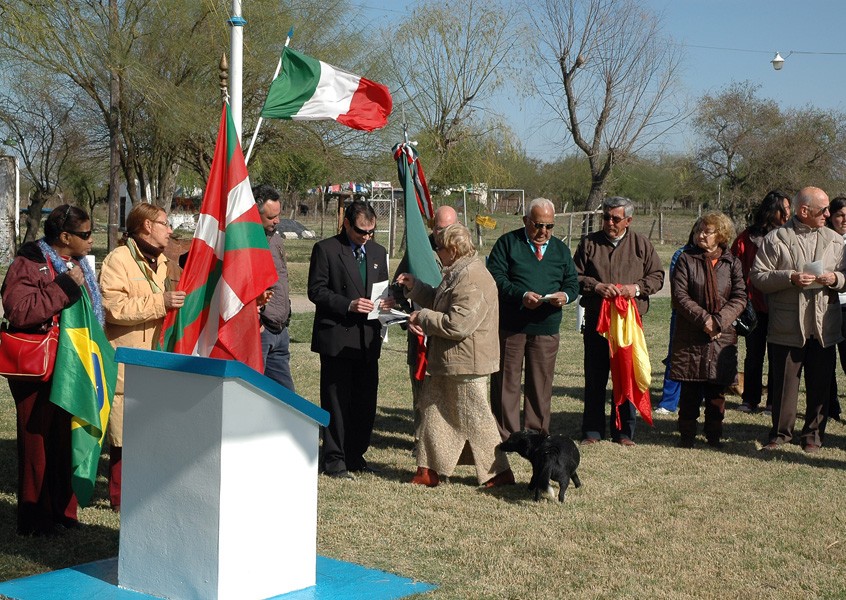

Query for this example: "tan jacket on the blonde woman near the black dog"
[408,254,499,375]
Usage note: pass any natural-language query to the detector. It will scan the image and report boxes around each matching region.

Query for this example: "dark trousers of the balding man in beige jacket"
[768,339,835,446]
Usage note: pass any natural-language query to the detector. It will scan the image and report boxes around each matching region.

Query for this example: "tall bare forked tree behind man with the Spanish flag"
[527,0,684,210]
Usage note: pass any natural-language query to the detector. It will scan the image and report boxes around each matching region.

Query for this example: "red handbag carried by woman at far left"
[0,317,59,381]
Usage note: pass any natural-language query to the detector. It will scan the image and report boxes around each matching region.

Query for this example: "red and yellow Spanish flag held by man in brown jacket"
[596,296,652,428]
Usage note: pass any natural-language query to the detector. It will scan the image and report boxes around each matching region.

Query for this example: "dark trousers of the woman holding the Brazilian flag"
[9,381,77,534]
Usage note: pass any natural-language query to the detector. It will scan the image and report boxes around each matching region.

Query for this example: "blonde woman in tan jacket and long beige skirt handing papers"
[397,223,514,487]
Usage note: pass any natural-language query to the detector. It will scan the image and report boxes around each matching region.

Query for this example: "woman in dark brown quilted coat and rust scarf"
[670,212,746,448]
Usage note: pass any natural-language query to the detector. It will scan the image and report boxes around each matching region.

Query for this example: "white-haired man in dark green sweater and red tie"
[488,198,578,440]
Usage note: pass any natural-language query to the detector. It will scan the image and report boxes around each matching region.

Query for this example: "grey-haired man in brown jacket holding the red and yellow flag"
[574,196,664,446]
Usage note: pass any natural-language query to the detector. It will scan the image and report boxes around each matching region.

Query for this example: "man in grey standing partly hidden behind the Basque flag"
[253,184,294,392]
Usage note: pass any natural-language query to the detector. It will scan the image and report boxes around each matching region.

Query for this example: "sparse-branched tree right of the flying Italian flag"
[389,0,519,180]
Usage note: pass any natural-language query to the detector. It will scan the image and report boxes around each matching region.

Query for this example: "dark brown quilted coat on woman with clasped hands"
[670,247,747,385]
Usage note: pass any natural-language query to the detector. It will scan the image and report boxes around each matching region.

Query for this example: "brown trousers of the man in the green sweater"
[491,329,561,440]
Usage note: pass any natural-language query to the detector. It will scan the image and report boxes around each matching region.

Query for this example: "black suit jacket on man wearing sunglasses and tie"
[308,231,388,360]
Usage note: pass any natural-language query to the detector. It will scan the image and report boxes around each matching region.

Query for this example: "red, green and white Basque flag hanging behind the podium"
[160,103,278,373]
